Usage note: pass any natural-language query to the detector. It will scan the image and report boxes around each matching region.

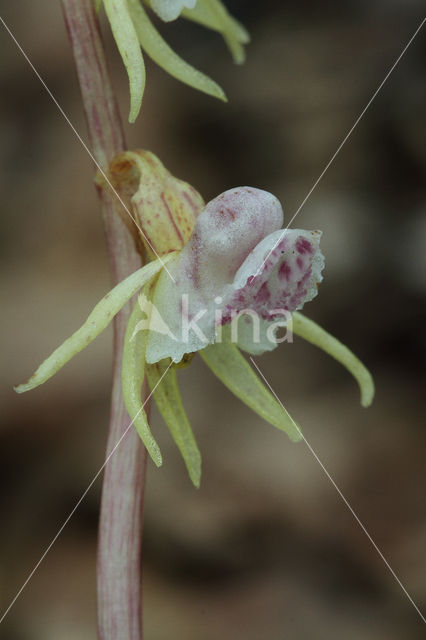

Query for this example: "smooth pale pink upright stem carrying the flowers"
[62,0,146,640]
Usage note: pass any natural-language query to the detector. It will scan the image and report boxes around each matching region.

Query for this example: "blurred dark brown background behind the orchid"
[0,0,426,640]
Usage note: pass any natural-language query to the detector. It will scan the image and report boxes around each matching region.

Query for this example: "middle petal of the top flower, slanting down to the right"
[128,0,226,101]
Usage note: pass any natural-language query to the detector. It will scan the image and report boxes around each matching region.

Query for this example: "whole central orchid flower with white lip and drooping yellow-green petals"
[16,151,374,486]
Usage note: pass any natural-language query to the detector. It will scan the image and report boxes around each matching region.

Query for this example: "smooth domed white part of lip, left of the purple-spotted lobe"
[146,187,283,363]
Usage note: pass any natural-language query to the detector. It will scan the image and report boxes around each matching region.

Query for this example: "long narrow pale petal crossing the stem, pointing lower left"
[15,254,174,393]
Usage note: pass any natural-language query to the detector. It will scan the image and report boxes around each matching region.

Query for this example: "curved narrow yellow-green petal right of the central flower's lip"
[293,313,374,407]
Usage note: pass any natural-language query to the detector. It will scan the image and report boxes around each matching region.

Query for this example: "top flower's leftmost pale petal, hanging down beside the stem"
[103,0,145,122]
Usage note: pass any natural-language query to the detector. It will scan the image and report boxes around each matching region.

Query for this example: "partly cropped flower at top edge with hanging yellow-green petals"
[96,0,249,122]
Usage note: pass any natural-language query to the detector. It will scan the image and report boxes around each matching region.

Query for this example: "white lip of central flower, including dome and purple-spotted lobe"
[146,187,324,363]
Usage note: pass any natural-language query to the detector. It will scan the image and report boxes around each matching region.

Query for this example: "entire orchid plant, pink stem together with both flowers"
[15,0,374,640]
